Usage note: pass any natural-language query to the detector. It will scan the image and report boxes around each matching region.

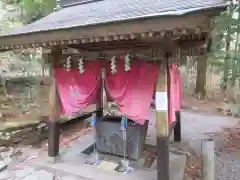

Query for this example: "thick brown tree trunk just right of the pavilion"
[195,55,207,99]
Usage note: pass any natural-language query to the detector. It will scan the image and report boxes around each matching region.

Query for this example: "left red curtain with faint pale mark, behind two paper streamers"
[54,61,101,115]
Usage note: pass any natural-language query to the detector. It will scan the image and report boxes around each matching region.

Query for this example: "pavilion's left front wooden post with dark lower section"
[48,47,60,162]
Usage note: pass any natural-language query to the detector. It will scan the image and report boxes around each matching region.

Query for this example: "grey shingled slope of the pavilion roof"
[2,0,226,37]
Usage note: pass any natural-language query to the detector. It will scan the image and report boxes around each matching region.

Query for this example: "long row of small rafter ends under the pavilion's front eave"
[1,28,206,49]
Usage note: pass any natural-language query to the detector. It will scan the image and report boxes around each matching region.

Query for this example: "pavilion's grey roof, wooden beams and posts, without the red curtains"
[0,0,227,180]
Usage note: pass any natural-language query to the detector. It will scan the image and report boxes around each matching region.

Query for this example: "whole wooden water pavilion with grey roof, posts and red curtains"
[0,0,226,180]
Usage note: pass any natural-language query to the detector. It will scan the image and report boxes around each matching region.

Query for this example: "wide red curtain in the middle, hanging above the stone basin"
[105,60,158,124]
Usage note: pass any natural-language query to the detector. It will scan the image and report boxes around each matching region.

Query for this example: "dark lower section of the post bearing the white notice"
[157,137,170,180]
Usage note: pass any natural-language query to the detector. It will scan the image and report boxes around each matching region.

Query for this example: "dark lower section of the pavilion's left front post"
[48,121,60,157]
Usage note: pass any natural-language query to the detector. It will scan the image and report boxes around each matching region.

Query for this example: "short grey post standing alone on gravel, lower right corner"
[201,139,215,180]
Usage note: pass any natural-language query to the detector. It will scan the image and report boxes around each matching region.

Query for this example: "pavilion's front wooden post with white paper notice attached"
[155,57,169,180]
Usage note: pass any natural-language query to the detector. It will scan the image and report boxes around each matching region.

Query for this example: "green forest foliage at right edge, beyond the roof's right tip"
[209,3,240,87]
